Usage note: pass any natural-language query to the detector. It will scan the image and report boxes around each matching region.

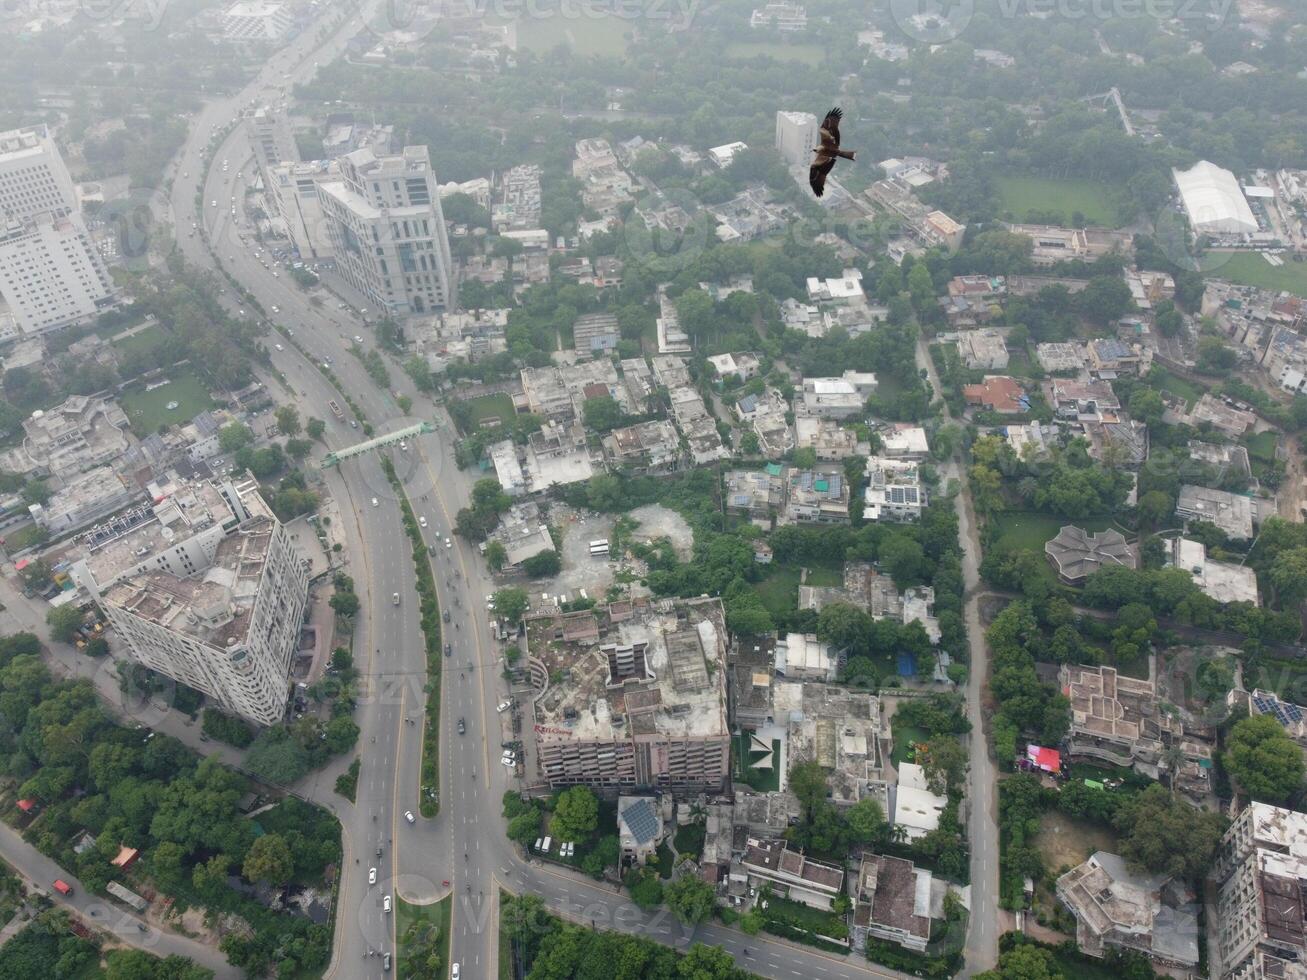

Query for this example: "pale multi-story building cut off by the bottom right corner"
[1214,802,1307,980]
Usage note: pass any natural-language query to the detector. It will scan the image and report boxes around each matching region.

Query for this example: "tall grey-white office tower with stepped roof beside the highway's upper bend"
[318,146,456,316]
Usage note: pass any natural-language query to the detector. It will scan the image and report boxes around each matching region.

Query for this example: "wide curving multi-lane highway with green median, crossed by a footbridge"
[158,3,935,980]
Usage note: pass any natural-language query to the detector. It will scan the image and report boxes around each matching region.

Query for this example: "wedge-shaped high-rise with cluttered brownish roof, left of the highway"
[72,481,308,725]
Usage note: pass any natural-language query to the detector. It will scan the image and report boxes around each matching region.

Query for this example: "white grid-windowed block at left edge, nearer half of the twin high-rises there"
[0,210,114,335]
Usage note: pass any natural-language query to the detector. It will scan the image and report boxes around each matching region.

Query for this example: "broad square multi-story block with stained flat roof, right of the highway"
[527,598,731,793]
